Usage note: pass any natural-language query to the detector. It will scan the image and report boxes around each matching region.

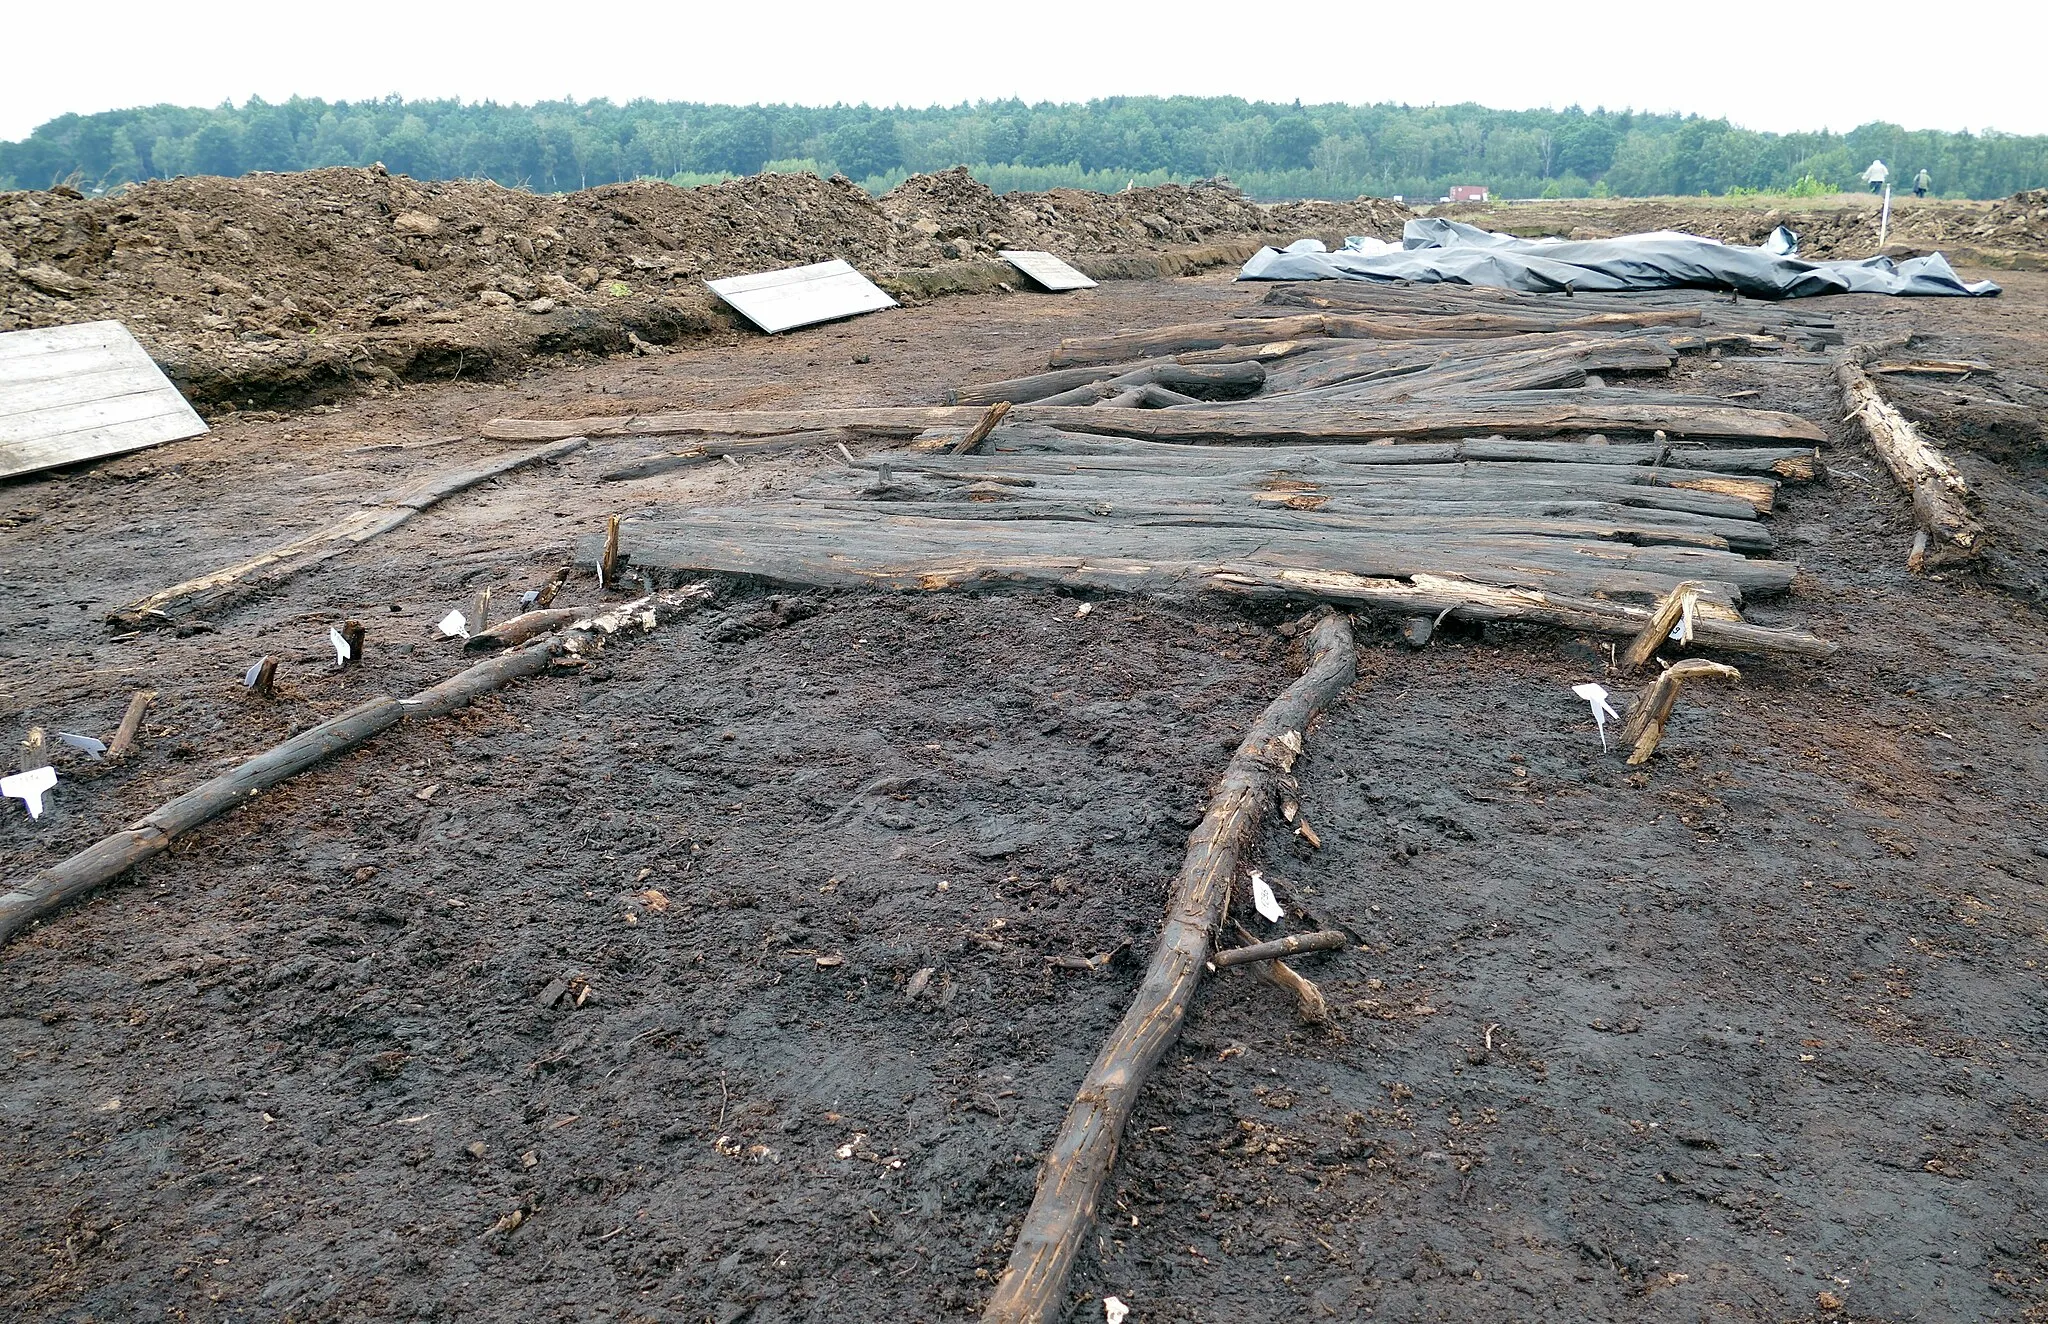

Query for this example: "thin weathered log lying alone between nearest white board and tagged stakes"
[106,435,586,629]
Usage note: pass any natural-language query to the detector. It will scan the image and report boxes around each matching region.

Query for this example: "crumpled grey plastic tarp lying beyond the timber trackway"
[1237,217,1999,299]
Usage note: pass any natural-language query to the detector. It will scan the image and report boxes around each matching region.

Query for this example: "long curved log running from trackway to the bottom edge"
[981,615,1358,1324]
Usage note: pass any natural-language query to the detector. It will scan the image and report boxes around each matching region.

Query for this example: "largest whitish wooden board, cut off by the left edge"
[0,322,207,478]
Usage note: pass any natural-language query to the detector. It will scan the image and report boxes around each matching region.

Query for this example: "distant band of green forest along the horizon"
[0,96,2048,201]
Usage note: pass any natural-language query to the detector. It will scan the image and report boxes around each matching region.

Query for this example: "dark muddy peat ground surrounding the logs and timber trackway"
[0,262,2048,1324]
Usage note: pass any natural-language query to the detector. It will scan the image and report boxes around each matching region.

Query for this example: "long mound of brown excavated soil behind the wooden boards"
[0,168,1407,411]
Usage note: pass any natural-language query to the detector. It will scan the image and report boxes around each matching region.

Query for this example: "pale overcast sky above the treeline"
[0,0,2048,139]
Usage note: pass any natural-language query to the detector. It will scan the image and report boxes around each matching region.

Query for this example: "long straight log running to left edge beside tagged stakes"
[0,584,711,945]
